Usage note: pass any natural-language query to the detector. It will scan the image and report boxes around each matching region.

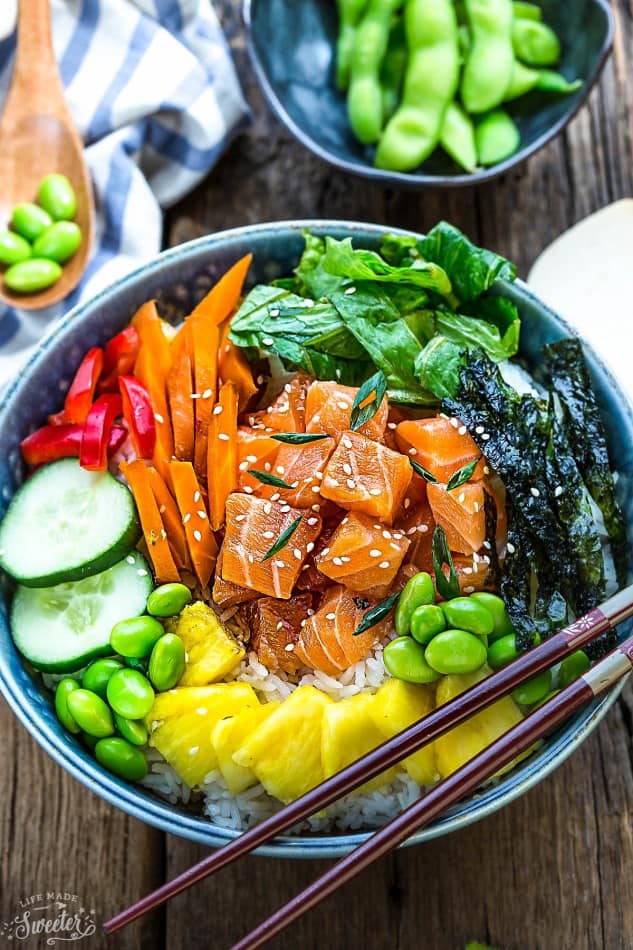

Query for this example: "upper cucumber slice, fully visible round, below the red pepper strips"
[0,459,141,587]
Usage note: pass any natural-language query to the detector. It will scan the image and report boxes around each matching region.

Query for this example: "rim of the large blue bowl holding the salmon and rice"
[0,219,633,858]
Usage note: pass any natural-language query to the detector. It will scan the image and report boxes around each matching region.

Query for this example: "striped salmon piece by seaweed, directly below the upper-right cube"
[427,481,486,554]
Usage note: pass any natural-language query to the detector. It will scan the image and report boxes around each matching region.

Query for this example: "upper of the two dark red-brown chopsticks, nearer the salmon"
[103,586,633,933]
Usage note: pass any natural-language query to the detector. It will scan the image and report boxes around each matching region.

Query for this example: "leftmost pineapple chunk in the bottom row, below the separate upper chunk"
[145,683,259,788]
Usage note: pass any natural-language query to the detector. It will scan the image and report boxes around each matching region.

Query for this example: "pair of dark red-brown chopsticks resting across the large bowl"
[103,586,633,950]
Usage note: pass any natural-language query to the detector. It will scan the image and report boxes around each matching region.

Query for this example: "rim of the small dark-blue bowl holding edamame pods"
[242,0,615,190]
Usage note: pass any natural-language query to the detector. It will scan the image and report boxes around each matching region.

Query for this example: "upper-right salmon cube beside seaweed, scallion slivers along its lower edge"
[396,416,486,482]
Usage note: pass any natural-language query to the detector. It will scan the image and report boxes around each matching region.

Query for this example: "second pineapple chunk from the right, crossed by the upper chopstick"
[369,679,439,785]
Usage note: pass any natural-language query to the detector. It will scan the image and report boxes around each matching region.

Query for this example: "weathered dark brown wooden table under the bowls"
[0,0,633,950]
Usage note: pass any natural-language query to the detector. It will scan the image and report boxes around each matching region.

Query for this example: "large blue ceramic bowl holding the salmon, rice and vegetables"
[0,221,633,858]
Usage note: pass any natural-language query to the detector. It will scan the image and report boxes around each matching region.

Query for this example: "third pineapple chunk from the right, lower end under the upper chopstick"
[321,693,396,794]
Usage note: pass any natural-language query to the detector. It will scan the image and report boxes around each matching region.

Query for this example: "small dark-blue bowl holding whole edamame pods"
[243,0,613,188]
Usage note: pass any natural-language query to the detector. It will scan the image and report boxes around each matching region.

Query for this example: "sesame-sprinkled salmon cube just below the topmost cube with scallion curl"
[321,431,413,524]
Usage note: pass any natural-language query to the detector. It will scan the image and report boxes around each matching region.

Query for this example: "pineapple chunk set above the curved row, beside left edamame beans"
[166,601,245,686]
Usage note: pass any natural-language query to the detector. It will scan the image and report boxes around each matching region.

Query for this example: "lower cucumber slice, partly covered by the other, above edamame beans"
[11,551,153,673]
